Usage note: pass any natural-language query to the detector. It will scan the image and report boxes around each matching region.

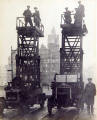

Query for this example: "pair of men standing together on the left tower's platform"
[23,5,41,27]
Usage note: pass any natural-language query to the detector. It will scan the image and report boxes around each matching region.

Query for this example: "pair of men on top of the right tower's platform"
[64,1,85,25]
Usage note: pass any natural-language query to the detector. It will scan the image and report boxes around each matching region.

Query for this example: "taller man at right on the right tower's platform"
[74,1,85,26]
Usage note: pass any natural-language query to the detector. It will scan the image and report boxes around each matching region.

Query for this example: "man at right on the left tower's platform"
[33,7,41,27]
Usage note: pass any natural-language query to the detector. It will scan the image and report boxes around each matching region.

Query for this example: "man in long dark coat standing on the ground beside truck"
[85,78,96,114]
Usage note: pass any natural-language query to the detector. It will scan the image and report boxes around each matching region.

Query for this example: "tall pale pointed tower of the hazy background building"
[48,28,60,82]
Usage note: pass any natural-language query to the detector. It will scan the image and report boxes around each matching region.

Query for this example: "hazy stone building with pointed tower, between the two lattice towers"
[40,28,60,84]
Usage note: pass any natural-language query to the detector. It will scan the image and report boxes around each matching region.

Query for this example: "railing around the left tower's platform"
[16,17,44,33]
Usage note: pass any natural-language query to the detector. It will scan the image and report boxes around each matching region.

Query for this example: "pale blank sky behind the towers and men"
[0,0,97,80]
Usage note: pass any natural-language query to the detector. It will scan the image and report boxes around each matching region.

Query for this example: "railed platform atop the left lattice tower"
[16,17,44,37]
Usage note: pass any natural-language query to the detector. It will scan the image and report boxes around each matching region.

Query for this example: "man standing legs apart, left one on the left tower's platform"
[23,5,33,27]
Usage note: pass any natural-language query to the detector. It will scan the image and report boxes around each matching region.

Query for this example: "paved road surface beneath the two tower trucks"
[0,104,97,120]
